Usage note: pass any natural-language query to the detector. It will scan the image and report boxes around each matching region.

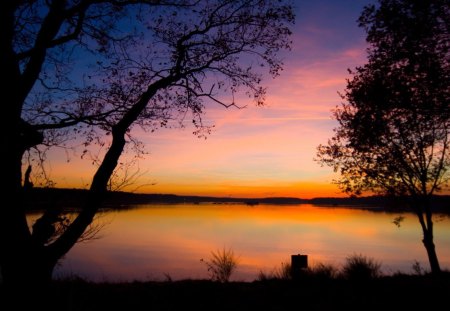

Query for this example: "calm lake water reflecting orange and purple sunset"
[30,204,450,281]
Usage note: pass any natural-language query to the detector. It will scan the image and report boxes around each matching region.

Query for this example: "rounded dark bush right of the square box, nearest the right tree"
[342,254,381,280]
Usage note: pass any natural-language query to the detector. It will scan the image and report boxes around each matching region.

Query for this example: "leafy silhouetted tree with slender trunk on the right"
[317,0,450,273]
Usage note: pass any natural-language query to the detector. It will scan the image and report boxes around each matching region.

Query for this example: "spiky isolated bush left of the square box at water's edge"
[200,248,238,283]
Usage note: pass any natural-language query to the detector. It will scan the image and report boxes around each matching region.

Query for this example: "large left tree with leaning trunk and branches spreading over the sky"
[0,0,294,285]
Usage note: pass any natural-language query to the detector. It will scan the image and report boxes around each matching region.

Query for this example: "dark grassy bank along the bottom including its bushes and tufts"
[0,255,450,311]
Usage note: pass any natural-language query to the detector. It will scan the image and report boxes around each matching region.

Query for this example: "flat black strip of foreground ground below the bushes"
[0,273,450,311]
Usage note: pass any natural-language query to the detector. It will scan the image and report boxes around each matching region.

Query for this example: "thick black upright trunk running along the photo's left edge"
[0,1,37,285]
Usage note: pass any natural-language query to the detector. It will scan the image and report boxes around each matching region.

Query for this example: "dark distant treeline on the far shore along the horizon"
[25,188,450,213]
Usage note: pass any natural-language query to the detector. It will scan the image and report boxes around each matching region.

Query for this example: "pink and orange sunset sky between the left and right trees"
[48,0,374,198]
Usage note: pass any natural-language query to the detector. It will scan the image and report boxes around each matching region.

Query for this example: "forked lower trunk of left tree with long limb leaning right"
[0,61,178,291]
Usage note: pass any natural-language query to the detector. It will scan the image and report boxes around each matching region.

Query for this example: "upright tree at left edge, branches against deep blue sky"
[0,0,195,284]
